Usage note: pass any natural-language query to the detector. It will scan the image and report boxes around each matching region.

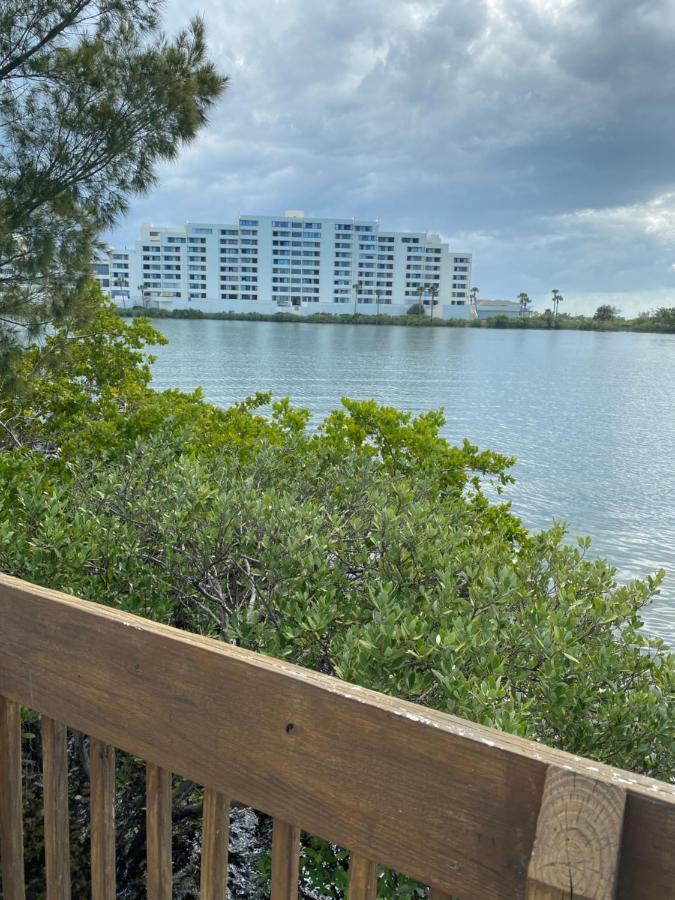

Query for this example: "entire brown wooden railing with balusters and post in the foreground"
[0,576,675,900]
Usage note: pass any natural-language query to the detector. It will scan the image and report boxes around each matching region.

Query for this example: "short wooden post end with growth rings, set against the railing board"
[527,766,628,900]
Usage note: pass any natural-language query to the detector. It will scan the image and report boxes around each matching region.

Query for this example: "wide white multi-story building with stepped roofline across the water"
[94,211,471,317]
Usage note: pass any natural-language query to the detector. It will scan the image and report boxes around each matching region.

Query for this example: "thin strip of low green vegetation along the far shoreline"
[118,306,675,334]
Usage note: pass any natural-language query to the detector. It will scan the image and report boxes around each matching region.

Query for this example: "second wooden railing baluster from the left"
[42,716,70,900]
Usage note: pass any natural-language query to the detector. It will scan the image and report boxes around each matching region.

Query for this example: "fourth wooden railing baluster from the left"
[146,763,173,900]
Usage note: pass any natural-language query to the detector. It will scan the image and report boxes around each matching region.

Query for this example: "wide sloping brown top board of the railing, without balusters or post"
[0,576,675,900]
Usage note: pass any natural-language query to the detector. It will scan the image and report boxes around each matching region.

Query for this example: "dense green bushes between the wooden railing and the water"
[0,295,675,897]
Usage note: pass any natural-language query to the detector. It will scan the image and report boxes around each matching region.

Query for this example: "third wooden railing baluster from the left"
[89,738,116,900]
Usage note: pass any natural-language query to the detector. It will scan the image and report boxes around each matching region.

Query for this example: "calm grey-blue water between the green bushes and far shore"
[153,320,675,644]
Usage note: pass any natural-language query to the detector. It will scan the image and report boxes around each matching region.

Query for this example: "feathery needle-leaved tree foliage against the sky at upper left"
[0,0,225,370]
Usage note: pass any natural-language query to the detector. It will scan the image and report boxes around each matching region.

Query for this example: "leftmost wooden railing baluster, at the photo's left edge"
[0,696,26,900]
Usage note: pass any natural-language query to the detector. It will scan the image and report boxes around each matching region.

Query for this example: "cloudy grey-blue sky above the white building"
[111,0,675,313]
